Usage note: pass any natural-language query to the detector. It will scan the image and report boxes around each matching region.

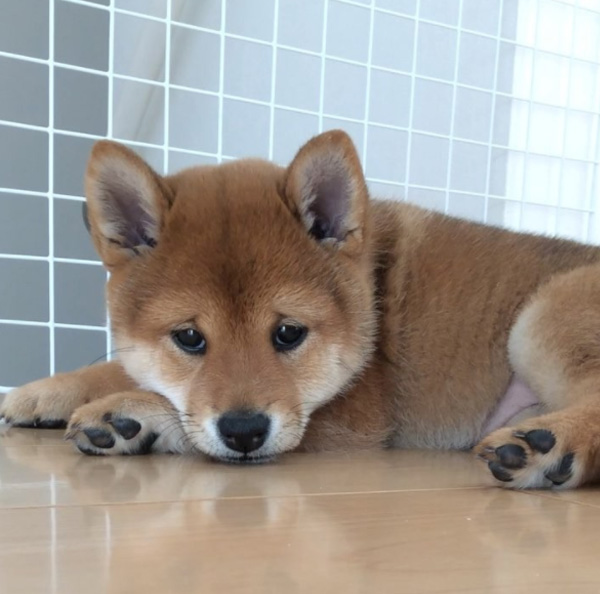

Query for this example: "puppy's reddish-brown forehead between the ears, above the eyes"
[154,160,338,302]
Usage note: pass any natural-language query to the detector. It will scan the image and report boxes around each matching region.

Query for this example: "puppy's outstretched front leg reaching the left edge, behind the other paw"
[0,361,136,429]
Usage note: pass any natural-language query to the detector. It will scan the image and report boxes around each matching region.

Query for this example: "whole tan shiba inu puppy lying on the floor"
[1,131,600,488]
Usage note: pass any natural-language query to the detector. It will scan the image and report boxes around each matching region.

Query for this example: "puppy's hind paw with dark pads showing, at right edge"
[475,411,598,489]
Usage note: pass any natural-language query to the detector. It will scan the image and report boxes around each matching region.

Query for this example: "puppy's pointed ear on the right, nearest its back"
[284,130,369,247]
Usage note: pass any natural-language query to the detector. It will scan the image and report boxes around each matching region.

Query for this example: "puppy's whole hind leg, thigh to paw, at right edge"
[475,266,600,488]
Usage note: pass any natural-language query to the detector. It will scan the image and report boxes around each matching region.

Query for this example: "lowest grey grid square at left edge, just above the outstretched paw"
[0,324,50,387]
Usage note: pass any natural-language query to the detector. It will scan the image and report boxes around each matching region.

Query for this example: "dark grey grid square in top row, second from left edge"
[54,2,109,71]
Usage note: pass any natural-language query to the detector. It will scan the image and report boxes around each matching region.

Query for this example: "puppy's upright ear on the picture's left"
[85,140,173,269]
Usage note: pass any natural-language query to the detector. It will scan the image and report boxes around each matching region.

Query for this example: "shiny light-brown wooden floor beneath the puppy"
[0,428,600,594]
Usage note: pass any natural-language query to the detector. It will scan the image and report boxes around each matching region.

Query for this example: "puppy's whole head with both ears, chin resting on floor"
[86,131,375,461]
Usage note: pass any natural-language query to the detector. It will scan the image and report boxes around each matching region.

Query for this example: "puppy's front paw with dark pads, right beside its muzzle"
[65,392,186,456]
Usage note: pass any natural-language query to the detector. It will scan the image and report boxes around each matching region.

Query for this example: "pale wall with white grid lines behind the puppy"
[0,0,600,391]
